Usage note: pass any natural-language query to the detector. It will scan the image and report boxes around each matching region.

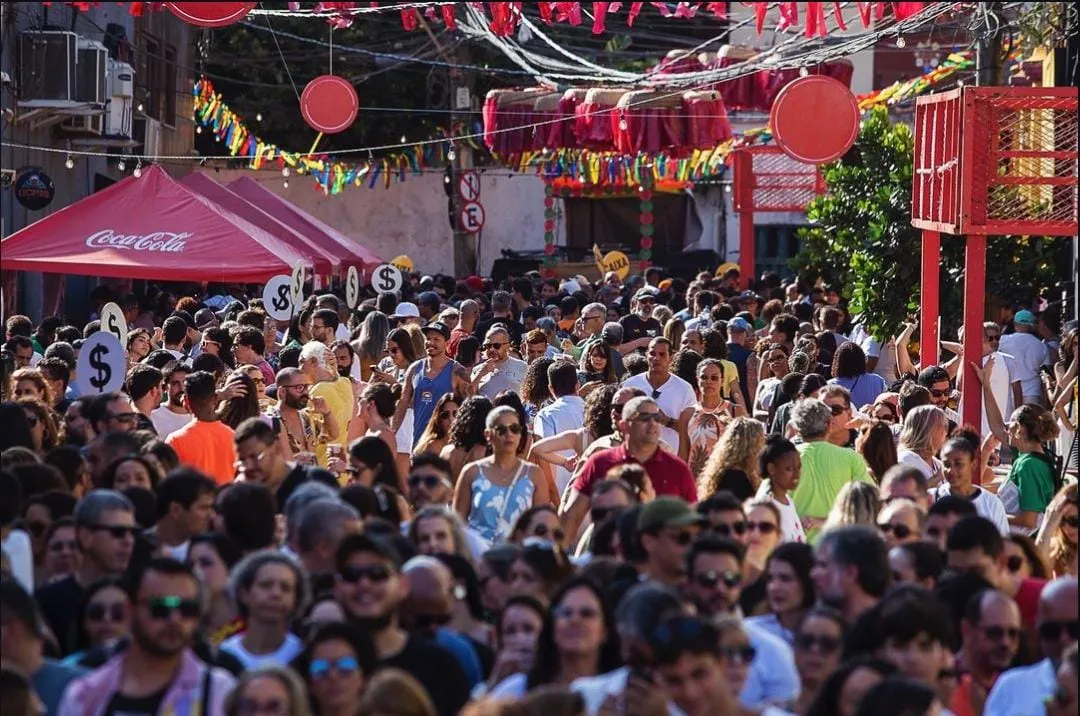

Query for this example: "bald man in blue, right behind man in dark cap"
[401,555,484,689]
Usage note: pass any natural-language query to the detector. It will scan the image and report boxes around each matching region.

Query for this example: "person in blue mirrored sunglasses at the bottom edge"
[294,622,378,716]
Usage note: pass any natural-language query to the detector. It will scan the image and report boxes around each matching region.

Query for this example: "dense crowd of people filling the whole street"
[0,268,1080,716]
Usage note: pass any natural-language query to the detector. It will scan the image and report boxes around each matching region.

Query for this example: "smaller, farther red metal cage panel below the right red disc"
[731,145,825,212]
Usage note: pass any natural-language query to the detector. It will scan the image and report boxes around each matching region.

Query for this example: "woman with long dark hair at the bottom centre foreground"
[491,577,620,698]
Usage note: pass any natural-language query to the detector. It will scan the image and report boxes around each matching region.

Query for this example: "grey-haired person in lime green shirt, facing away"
[791,397,874,542]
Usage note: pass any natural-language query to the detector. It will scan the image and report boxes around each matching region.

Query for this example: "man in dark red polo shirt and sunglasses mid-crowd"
[563,397,698,535]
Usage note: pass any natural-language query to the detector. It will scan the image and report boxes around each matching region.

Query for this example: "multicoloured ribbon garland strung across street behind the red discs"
[192,46,974,195]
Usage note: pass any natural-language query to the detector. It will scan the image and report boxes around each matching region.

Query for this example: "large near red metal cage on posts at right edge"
[912,87,1078,235]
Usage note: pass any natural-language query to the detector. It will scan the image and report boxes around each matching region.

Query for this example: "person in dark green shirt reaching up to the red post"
[971,355,1058,532]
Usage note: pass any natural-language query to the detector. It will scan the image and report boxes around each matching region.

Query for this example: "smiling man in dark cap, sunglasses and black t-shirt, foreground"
[334,535,469,716]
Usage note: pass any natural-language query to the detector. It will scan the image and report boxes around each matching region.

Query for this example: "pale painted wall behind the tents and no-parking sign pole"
[212,168,565,275]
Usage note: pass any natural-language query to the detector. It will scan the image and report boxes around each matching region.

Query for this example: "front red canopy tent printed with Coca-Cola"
[0,166,311,283]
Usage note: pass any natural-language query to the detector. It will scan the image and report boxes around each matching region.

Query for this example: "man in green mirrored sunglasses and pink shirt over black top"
[57,557,235,716]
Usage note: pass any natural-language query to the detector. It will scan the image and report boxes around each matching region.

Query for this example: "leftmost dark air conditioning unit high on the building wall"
[18,30,79,103]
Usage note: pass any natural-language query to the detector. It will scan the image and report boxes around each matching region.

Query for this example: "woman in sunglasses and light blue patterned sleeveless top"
[454,406,552,544]
